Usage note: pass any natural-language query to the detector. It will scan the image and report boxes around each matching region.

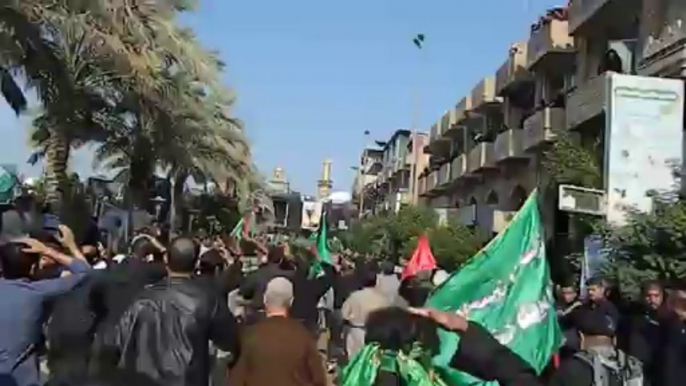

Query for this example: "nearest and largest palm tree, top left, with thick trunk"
[0,0,239,213]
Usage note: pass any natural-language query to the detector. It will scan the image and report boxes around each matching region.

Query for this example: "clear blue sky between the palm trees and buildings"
[0,0,566,193]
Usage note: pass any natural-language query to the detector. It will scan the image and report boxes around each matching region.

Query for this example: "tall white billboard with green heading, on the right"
[603,74,684,226]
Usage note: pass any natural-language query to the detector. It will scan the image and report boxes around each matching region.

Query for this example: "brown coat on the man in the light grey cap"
[229,317,326,386]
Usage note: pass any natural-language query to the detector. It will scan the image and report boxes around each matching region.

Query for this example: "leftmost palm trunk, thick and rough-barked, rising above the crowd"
[45,129,70,215]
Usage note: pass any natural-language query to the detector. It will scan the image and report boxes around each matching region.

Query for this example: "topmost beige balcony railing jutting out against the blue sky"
[527,19,574,68]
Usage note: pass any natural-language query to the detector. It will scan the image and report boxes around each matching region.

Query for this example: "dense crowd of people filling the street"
[0,214,686,386]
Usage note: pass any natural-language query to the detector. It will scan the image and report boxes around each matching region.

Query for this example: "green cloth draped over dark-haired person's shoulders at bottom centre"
[340,344,447,386]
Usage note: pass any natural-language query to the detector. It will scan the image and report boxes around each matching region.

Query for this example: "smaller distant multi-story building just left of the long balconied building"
[353,130,428,215]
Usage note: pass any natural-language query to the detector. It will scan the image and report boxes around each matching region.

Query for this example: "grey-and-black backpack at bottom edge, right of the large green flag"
[574,349,643,386]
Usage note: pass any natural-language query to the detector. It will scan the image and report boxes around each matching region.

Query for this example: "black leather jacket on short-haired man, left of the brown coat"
[98,278,239,386]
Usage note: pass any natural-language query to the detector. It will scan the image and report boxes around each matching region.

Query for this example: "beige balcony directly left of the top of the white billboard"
[566,73,610,130]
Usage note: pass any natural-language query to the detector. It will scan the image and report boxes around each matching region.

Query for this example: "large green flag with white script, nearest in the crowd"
[427,191,562,385]
